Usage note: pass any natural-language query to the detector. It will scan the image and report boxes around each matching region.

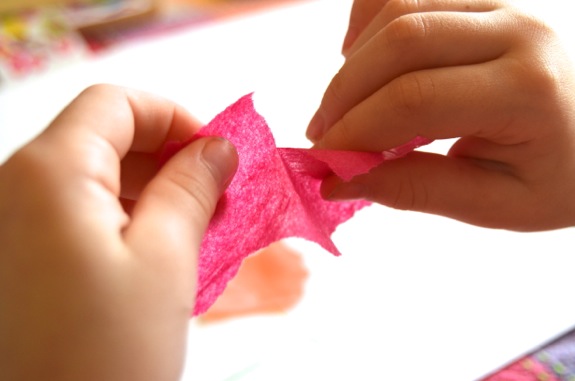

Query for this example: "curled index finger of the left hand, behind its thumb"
[39,85,199,199]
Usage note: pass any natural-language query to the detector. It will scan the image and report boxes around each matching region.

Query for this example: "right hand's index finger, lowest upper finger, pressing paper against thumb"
[315,58,545,152]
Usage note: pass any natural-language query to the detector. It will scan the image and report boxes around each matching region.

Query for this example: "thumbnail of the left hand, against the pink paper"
[202,137,238,189]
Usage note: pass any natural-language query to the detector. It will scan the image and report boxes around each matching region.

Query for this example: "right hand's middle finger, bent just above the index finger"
[307,8,516,142]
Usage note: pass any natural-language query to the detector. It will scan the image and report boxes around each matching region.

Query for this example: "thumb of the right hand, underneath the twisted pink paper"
[322,152,539,230]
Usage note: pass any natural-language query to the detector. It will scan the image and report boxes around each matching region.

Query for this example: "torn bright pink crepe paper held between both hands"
[163,94,428,315]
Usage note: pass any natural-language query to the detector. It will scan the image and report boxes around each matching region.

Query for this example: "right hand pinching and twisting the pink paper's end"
[308,0,575,230]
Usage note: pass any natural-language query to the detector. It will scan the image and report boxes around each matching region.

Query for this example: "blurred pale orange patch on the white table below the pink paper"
[200,241,308,322]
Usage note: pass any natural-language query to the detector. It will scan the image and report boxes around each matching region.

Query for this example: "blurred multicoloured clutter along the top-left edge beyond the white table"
[0,0,302,82]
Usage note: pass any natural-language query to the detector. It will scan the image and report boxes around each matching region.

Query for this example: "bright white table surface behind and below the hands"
[0,0,575,381]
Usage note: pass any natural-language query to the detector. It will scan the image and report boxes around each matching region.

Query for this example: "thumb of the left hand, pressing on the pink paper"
[126,137,238,255]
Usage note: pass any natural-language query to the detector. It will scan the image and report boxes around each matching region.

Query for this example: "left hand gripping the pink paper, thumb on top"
[0,85,237,381]
